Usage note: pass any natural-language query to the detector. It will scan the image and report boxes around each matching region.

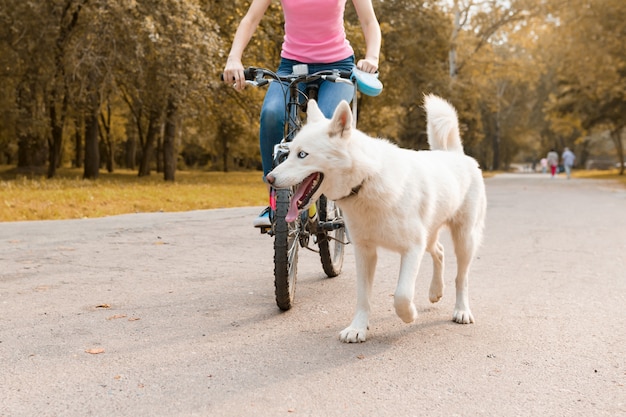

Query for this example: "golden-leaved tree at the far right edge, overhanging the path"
[547,0,626,175]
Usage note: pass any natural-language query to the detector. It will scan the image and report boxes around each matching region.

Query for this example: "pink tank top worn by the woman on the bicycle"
[281,0,354,64]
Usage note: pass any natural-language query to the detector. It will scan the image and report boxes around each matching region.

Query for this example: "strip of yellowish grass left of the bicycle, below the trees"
[0,167,267,221]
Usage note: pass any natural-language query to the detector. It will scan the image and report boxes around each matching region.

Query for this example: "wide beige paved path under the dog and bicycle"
[0,174,626,417]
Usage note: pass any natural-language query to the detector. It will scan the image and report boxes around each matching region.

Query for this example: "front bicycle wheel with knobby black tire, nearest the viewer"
[274,189,300,311]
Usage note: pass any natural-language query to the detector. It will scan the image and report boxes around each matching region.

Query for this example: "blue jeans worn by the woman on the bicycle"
[259,56,354,179]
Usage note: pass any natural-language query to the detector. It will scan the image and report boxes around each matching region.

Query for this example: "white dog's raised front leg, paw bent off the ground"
[393,245,424,323]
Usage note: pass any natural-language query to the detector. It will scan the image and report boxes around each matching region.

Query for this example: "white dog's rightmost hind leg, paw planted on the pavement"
[450,227,479,324]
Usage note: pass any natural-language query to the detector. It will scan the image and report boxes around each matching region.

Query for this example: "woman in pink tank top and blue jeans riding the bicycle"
[224,0,381,227]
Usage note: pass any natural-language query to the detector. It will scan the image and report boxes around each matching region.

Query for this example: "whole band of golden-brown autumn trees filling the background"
[0,0,626,180]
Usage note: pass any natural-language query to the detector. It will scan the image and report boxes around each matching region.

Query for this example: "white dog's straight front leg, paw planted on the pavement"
[339,244,378,343]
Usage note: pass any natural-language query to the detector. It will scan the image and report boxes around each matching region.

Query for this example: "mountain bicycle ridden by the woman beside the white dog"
[224,64,382,311]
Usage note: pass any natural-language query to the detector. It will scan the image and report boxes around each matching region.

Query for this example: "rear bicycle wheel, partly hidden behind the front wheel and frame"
[317,195,346,278]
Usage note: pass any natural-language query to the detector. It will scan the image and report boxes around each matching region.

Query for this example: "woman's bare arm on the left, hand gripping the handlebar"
[224,0,272,90]
